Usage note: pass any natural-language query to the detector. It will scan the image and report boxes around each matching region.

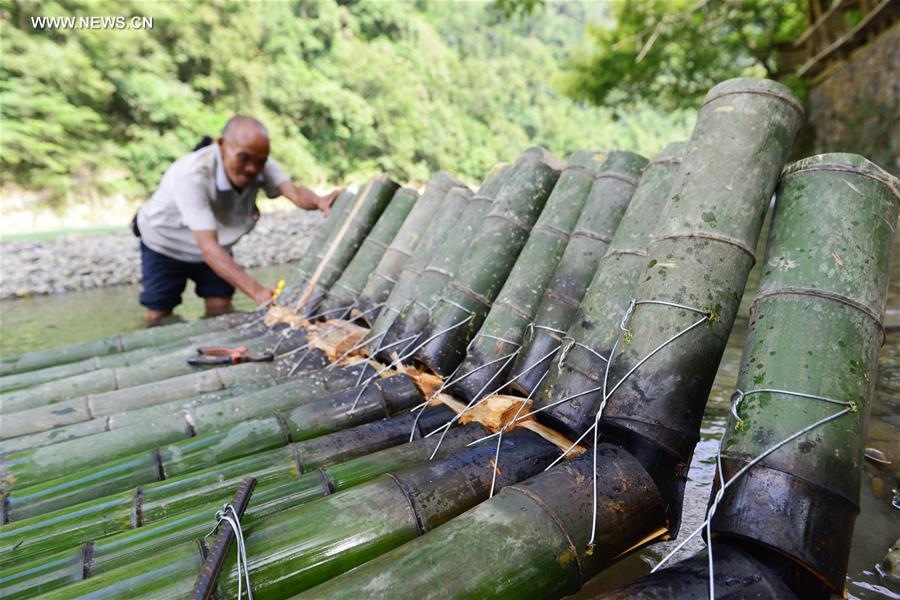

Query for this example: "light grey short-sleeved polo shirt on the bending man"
[138,144,289,262]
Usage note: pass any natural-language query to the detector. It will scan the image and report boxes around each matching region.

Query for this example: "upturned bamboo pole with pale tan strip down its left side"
[295,177,400,316]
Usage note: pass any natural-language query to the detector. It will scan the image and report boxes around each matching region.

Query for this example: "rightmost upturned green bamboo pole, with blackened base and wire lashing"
[712,154,900,597]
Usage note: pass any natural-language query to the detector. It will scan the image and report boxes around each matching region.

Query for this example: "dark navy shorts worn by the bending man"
[140,242,234,312]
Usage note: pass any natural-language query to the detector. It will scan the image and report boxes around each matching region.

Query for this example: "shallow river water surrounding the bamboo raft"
[0,256,900,599]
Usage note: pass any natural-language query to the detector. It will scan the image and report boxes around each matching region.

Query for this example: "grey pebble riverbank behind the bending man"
[0,210,323,299]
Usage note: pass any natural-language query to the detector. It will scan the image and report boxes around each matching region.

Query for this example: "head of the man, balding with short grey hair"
[217,115,269,188]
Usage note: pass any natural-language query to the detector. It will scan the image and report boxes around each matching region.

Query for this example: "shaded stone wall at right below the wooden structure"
[808,22,900,176]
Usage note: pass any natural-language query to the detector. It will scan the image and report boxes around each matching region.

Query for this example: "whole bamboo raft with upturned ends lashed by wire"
[0,79,900,598]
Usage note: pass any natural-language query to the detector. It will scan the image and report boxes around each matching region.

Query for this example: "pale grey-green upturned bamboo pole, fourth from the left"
[354,171,460,324]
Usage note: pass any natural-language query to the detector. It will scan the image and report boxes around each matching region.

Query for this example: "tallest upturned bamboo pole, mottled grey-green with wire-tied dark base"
[603,78,803,478]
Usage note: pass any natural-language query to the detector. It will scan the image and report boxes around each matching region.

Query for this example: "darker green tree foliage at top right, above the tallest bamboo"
[564,0,806,110]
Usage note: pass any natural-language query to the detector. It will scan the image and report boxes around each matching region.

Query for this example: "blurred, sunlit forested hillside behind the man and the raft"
[0,0,692,202]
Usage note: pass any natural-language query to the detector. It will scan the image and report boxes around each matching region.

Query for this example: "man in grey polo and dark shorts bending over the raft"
[137,116,339,325]
